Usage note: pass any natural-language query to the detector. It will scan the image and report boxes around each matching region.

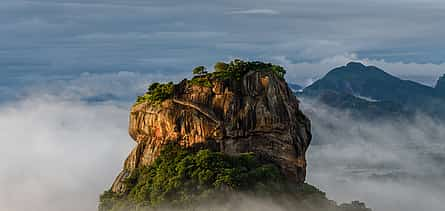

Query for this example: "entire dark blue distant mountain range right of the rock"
[301,62,445,117]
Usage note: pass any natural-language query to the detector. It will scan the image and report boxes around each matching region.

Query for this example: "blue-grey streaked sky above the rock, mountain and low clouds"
[0,0,445,97]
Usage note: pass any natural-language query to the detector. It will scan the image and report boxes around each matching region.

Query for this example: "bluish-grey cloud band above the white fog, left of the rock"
[0,71,191,104]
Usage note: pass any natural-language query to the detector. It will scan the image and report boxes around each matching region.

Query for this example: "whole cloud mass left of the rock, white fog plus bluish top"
[0,72,186,211]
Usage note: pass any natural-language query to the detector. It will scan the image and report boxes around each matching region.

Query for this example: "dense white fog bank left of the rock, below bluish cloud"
[0,96,132,211]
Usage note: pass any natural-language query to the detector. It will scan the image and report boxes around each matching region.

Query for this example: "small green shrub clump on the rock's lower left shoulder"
[136,82,174,104]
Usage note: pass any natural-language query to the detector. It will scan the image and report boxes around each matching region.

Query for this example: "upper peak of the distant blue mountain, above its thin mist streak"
[304,62,434,103]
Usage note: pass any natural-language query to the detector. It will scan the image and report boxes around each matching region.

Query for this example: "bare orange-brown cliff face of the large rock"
[111,71,311,193]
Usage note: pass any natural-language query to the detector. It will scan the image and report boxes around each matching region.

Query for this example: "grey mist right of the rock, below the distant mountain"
[302,100,445,211]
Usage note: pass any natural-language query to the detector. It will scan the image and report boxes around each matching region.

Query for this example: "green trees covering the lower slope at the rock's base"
[99,144,325,211]
